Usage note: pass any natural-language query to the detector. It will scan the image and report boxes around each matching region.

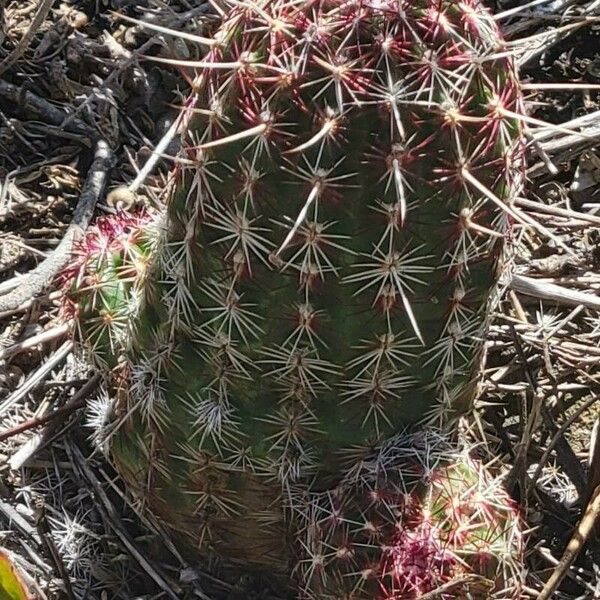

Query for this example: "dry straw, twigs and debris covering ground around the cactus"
[0,0,600,600]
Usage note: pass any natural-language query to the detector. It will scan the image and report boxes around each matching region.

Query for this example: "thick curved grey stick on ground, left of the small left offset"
[0,140,112,313]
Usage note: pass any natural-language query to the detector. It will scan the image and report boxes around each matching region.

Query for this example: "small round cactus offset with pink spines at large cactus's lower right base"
[296,431,523,600]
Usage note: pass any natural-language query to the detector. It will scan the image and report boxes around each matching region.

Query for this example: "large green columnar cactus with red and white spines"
[61,0,524,584]
